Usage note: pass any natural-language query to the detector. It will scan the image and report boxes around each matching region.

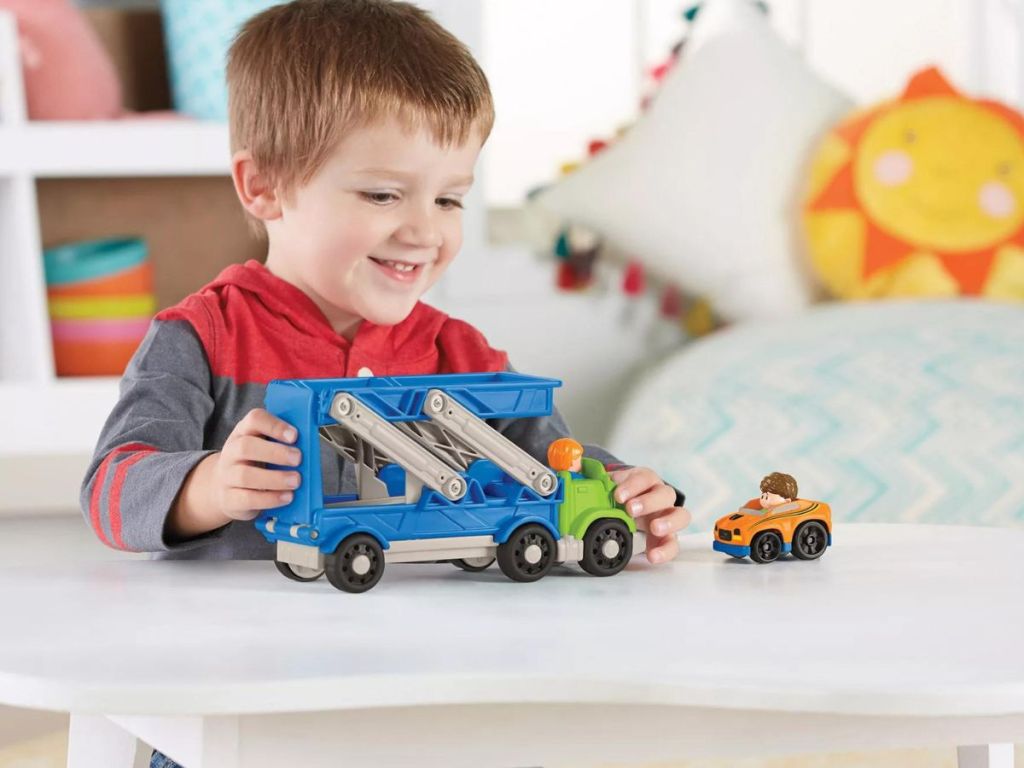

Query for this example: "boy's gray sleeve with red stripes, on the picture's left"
[81,321,223,552]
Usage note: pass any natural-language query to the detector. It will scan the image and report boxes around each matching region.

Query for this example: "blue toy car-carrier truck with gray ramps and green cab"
[255,372,636,592]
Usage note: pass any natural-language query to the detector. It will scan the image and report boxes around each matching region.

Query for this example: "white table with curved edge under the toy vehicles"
[0,525,1024,768]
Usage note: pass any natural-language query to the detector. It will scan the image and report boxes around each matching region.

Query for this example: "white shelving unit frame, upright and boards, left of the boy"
[0,10,230,458]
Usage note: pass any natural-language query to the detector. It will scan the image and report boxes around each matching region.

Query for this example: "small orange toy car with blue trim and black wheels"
[715,499,831,562]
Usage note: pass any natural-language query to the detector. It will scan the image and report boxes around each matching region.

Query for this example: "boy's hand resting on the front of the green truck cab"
[608,467,690,563]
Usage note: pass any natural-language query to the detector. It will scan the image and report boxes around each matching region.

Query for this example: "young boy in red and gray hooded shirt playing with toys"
[82,0,689,562]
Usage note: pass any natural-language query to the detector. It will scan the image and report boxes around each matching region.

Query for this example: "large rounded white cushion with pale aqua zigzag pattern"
[605,299,1024,528]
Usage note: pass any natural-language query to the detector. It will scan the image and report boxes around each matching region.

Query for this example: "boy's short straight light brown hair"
[227,0,495,201]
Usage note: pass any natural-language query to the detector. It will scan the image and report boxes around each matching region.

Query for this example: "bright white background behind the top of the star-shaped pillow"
[482,0,1024,207]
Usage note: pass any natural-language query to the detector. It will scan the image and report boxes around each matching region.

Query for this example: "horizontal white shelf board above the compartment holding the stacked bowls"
[0,118,230,178]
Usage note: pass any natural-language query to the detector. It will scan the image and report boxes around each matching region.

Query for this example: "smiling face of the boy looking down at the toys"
[266,113,480,338]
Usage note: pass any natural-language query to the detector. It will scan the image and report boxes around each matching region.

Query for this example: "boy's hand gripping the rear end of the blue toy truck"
[210,408,302,520]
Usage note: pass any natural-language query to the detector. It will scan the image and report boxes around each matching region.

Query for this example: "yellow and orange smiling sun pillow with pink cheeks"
[804,69,1024,300]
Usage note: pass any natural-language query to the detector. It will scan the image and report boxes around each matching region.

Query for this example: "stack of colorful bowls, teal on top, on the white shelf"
[43,238,157,376]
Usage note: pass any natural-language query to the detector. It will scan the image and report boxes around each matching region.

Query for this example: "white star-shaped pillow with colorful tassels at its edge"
[535,0,850,321]
